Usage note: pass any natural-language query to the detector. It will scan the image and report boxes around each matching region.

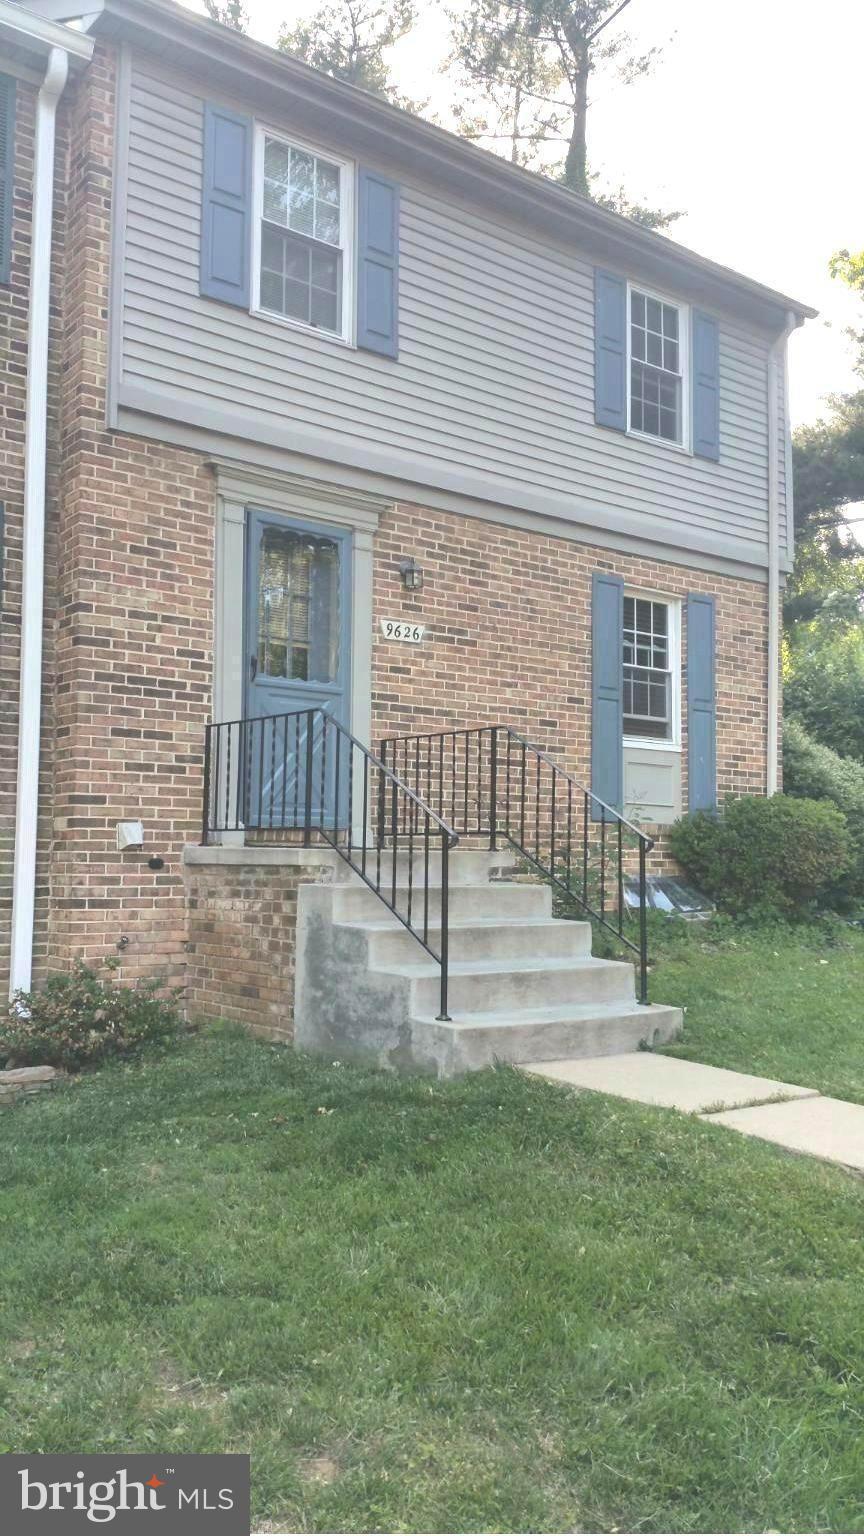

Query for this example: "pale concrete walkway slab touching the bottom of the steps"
[521,1051,811,1112]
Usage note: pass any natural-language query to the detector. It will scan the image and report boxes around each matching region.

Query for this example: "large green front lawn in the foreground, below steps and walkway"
[0,995,864,1531]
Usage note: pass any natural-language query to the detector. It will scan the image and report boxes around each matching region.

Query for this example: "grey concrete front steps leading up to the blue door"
[294,848,681,1077]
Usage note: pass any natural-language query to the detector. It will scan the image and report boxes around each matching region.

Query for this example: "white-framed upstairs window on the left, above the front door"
[252,127,354,341]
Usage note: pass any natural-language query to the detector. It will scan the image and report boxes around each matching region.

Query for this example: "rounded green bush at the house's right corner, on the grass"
[669,794,850,917]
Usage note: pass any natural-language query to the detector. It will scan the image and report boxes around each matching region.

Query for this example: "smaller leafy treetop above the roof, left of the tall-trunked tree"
[278,0,417,106]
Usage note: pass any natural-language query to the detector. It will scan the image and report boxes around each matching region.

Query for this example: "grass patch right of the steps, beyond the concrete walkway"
[650,919,864,1104]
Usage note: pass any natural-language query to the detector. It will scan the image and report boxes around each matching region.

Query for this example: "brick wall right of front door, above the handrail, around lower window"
[365,505,767,866]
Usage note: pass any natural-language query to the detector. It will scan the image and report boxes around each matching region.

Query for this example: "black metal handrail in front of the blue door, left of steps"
[201,708,460,1020]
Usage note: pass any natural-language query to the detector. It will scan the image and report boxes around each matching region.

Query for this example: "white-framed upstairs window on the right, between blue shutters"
[627,284,690,447]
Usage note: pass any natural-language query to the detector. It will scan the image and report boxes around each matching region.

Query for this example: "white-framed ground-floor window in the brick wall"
[624,591,681,746]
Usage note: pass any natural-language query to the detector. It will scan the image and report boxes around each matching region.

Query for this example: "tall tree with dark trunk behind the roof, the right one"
[449,0,678,227]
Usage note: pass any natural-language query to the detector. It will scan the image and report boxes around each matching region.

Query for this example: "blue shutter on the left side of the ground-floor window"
[590,571,624,820]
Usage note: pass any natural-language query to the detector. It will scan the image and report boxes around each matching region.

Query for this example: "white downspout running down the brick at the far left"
[9,48,69,995]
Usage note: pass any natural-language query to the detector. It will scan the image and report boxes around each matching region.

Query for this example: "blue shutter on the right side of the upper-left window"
[357,167,400,358]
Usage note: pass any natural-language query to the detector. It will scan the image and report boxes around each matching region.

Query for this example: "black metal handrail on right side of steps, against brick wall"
[380,725,653,1003]
